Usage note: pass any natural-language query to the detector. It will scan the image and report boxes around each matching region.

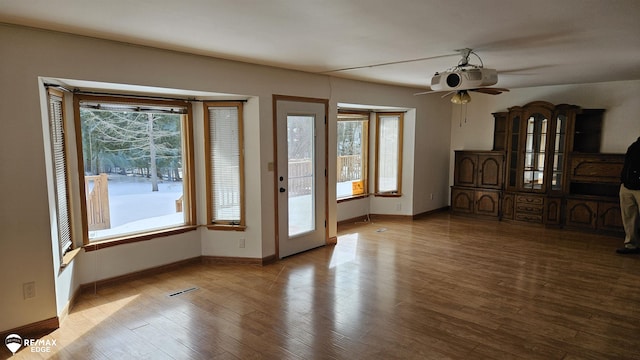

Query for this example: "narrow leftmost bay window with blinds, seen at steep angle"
[47,89,73,261]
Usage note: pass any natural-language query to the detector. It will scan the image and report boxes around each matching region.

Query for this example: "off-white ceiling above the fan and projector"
[0,0,640,88]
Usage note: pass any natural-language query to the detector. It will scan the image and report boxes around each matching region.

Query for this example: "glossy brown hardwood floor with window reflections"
[2,213,640,360]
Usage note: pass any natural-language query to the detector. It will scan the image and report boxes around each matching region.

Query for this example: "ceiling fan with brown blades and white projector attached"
[414,48,509,104]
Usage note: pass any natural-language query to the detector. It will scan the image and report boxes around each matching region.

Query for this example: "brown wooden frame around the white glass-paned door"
[271,94,330,259]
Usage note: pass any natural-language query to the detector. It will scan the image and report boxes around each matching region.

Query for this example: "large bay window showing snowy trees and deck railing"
[74,95,195,244]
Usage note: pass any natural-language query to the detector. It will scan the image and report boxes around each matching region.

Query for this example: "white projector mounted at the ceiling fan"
[431,67,498,91]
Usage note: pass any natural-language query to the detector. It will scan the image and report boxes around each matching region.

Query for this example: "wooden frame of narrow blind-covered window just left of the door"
[203,101,246,231]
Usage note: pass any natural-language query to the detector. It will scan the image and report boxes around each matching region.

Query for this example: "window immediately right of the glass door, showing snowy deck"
[336,113,369,200]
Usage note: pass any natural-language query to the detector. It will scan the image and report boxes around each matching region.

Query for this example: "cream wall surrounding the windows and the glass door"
[0,24,450,331]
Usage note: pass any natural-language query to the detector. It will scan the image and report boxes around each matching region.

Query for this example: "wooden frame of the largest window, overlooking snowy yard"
[73,94,197,251]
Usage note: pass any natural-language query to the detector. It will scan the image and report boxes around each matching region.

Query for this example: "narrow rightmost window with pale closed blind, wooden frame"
[375,113,403,196]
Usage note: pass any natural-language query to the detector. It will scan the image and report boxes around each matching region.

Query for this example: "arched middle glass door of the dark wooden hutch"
[522,113,549,191]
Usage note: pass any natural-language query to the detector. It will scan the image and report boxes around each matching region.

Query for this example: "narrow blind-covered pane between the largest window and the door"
[209,106,241,224]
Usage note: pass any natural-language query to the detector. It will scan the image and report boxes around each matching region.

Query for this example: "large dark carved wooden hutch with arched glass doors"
[451,101,624,233]
